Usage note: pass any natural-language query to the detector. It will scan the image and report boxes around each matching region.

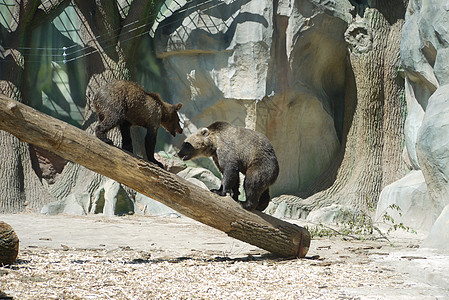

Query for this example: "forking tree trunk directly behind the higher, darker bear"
[45,0,158,204]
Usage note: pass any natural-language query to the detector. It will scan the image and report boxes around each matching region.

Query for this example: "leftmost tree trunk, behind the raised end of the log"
[0,1,67,213]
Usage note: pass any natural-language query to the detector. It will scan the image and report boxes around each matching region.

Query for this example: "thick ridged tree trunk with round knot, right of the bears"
[275,0,407,214]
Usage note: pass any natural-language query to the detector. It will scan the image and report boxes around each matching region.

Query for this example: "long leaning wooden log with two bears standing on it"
[0,95,310,257]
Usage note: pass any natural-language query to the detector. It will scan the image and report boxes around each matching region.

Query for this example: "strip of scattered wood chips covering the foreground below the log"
[0,247,405,299]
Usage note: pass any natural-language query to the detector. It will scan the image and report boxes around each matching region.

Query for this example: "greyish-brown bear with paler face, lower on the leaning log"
[178,122,279,211]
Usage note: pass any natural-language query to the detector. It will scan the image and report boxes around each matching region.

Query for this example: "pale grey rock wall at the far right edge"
[378,0,449,249]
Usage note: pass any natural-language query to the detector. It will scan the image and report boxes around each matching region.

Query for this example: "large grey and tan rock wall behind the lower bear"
[155,0,351,196]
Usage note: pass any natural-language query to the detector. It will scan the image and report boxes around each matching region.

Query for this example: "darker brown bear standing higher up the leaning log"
[93,80,182,168]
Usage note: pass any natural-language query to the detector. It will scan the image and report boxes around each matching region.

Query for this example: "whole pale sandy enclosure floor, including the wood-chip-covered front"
[0,214,449,299]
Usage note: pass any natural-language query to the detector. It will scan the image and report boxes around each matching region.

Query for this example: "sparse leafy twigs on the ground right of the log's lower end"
[306,204,416,241]
